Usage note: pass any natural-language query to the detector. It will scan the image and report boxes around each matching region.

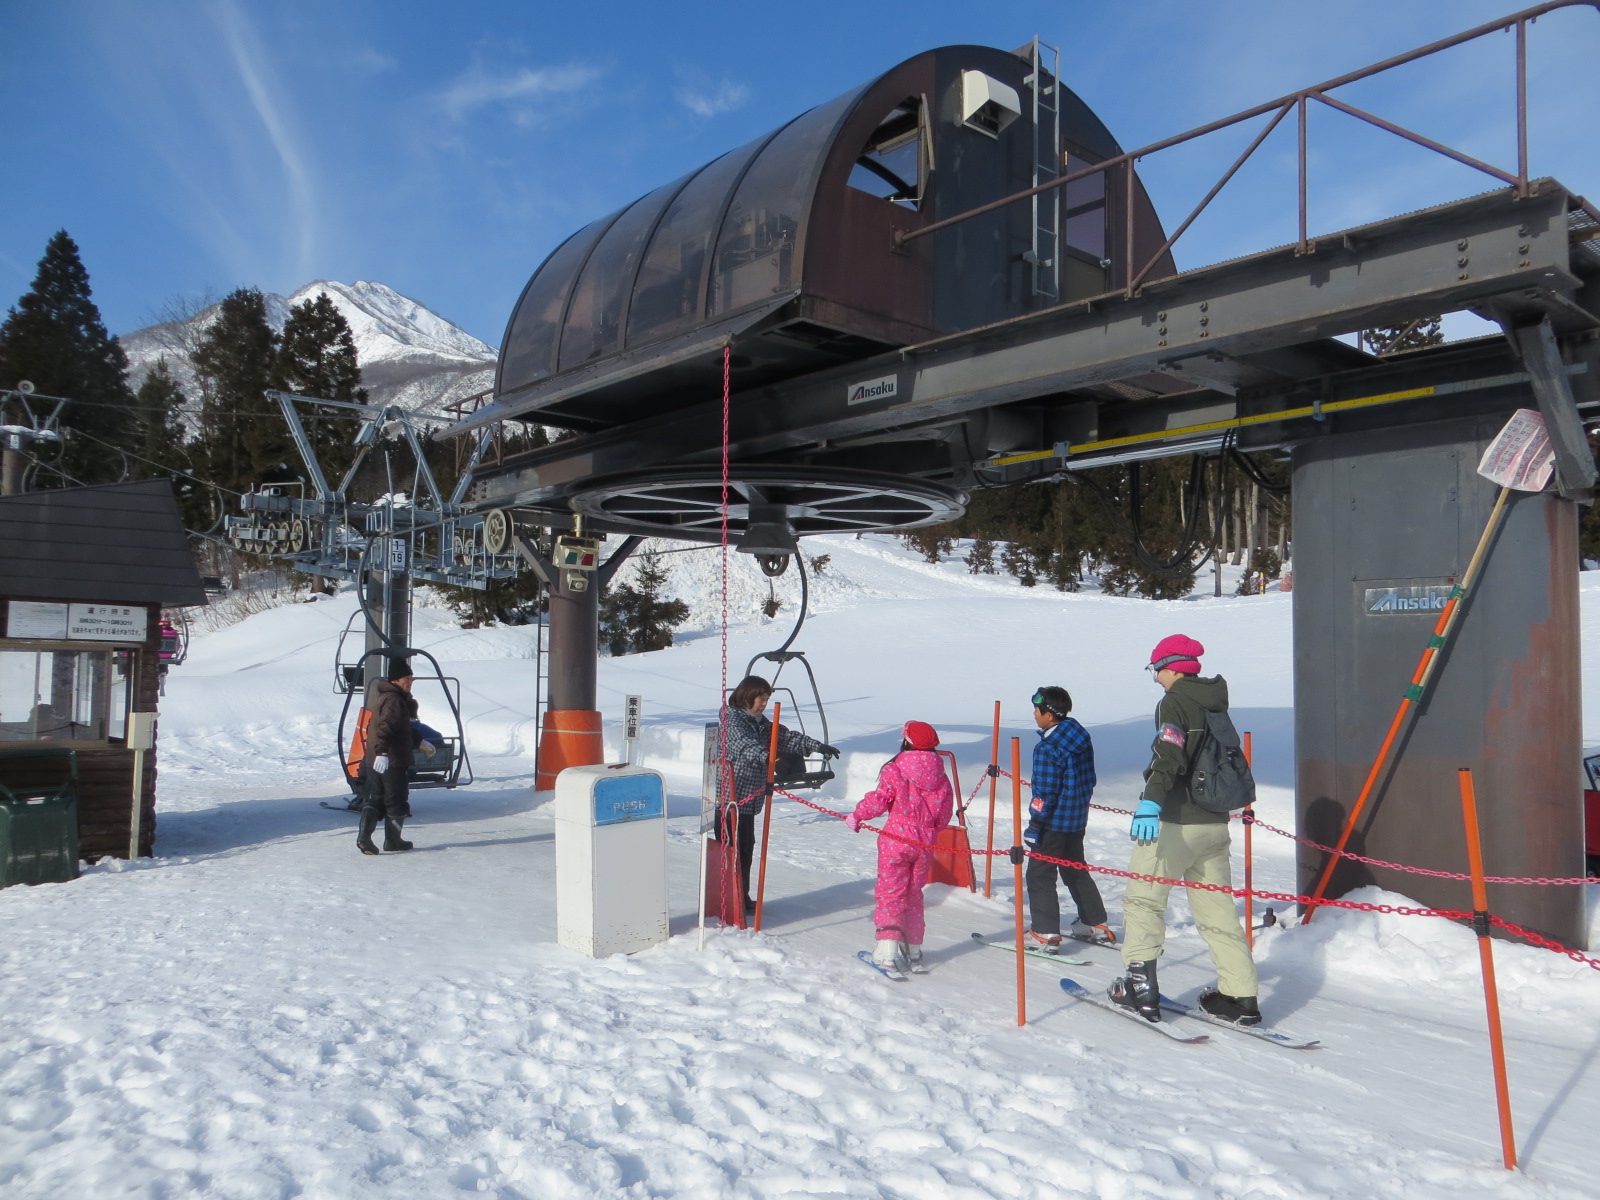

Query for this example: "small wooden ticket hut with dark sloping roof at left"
[0,480,206,861]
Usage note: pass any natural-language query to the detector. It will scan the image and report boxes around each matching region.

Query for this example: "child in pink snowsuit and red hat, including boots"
[845,722,955,979]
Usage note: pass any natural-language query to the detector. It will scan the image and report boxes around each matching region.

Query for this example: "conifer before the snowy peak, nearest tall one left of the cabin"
[277,291,366,482]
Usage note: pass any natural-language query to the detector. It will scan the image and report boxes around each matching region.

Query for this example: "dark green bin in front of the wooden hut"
[0,749,78,888]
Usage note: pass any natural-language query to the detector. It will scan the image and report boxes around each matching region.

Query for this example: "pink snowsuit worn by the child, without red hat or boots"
[854,750,955,946]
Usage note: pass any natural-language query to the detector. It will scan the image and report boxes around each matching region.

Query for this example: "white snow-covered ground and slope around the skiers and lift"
[0,538,1600,1200]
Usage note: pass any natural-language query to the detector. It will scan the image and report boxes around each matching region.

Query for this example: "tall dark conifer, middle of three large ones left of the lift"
[194,288,288,491]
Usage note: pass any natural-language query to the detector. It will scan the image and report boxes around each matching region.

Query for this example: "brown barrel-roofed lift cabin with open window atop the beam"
[475,46,1170,432]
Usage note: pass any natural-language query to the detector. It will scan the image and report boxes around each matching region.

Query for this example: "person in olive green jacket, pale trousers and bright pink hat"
[1110,634,1261,1026]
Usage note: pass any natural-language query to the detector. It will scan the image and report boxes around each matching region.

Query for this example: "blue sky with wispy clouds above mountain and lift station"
[0,0,1600,346]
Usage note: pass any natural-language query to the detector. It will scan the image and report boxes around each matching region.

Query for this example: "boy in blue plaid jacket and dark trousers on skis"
[1022,686,1117,954]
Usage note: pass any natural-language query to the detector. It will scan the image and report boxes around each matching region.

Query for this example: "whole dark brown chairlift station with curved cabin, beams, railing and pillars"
[232,0,1600,944]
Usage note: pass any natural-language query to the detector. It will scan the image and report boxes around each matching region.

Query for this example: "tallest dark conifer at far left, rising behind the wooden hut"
[0,229,133,483]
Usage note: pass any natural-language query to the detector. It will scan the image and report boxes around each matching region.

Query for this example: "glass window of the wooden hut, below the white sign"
[0,648,133,742]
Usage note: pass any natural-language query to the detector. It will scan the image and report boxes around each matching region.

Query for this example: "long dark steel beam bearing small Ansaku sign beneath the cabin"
[474,181,1600,507]
